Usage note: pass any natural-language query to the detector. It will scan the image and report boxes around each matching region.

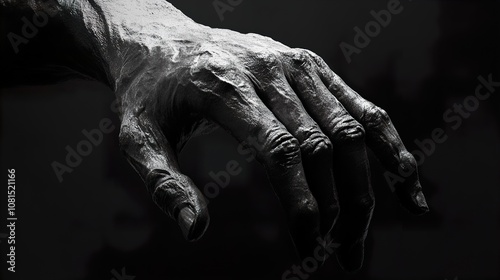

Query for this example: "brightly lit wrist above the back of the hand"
[59,0,199,90]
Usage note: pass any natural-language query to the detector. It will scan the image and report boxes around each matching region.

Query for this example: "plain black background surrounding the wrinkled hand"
[0,0,500,280]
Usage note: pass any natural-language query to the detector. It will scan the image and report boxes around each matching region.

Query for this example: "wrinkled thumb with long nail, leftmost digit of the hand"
[120,112,210,241]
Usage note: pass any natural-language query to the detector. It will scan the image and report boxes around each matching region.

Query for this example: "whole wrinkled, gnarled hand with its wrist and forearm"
[0,0,428,271]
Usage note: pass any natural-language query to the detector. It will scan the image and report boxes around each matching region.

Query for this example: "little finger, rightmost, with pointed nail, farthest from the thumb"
[313,56,429,215]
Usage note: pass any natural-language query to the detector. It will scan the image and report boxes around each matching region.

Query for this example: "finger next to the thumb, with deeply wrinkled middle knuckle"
[201,68,320,257]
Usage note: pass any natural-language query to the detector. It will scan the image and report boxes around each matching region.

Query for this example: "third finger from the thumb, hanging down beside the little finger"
[289,51,375,271]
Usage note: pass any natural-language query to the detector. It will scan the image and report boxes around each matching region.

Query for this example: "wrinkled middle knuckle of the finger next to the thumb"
[268,132,300,167]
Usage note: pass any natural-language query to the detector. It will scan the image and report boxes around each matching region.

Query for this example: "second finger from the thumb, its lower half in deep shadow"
[250,55,339,236]
